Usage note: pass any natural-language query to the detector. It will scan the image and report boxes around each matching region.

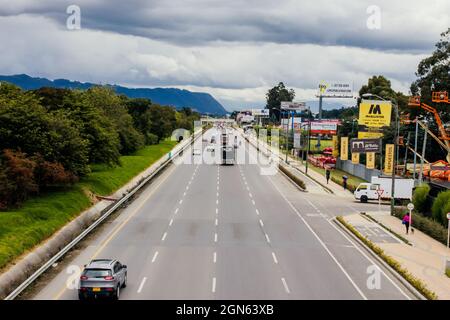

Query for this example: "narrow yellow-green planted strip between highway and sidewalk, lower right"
[336,216,438,300]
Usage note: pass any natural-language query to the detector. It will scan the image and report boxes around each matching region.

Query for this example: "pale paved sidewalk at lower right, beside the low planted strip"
[344,212,450,300]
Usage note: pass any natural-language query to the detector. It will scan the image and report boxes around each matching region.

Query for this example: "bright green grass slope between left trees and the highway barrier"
[0,140,176,270]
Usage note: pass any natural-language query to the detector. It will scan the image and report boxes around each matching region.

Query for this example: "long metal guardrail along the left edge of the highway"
[4,133,201,300]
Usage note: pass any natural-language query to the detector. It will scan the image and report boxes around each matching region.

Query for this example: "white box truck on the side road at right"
[353,176,414,202]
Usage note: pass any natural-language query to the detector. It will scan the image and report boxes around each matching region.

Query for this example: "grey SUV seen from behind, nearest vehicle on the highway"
[78,259,128,300]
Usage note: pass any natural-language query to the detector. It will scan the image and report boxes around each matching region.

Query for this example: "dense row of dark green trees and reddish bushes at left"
[0,83,200,209]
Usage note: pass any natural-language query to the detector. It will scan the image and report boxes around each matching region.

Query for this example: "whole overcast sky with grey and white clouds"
[0,0,450,110]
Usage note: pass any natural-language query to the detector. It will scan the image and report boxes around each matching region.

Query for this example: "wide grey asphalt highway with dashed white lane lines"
[32,129,413,300]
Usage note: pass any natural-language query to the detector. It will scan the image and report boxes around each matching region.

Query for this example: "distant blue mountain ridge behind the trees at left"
[0,74,227,115]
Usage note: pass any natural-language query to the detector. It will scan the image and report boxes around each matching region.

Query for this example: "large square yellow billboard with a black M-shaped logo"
[358,100,392,128]
